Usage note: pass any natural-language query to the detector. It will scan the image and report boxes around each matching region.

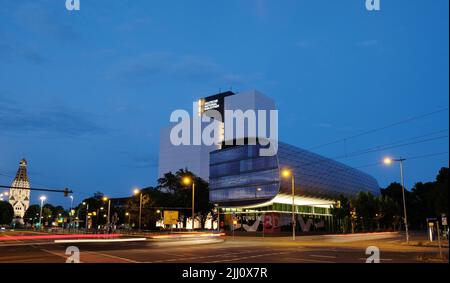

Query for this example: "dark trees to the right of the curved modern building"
[332,167,449,233]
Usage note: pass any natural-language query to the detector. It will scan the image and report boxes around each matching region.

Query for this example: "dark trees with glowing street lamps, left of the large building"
[0,169,213,229]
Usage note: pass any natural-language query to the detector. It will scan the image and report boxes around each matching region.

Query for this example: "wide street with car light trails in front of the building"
[0,232,448,263]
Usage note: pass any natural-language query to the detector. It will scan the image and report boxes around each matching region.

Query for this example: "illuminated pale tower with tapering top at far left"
[9,159,30,222]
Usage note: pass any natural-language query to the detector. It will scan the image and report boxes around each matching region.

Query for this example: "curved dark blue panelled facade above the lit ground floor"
[210,143,379,206]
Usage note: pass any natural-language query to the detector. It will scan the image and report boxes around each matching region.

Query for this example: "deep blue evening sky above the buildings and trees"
[0,0,449,209]
